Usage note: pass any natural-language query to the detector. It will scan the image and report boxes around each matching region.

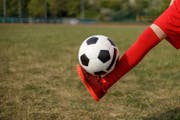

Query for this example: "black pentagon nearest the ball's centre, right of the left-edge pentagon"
[98,50,111,63]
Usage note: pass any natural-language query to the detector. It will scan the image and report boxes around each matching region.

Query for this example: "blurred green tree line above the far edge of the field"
[0,0,170,21]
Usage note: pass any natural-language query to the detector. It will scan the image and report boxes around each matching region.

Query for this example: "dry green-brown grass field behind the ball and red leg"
[0,24,180,120]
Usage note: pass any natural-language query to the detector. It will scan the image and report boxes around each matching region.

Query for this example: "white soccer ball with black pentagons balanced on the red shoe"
[78,35,119,76]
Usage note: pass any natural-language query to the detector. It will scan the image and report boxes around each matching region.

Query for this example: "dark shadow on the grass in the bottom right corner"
[143,107,180,120]
